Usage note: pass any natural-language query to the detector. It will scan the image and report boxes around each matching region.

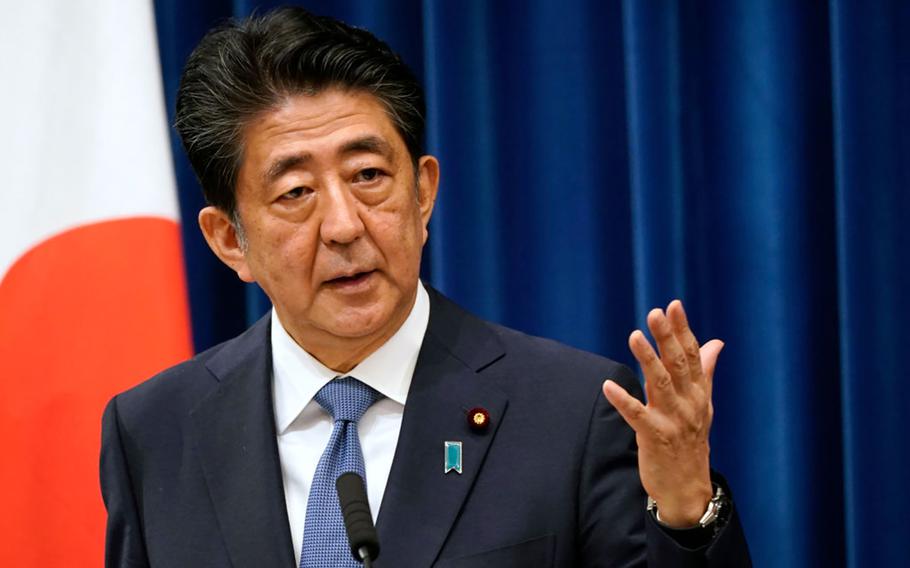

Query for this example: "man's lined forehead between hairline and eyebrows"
[241,89,407,177]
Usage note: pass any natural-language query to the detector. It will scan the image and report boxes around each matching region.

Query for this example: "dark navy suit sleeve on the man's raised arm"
[578,365,752,568]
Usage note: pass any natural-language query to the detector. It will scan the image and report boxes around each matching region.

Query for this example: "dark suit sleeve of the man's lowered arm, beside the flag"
[101,398,149,568]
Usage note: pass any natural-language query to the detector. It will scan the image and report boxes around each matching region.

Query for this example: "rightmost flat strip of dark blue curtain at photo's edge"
[831,1,910,566]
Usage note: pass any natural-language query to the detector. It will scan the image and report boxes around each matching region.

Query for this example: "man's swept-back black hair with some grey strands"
[175,7,426,220]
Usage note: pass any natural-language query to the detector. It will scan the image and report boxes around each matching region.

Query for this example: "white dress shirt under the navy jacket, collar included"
[271,283,430,563]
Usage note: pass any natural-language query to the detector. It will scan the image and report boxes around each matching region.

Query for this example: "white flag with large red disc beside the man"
[0,0,191,566]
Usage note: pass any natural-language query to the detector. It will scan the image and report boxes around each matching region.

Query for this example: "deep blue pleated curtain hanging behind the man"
[156,0,910,568]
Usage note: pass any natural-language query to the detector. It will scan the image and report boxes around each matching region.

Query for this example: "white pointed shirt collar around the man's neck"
[271,282,430,435]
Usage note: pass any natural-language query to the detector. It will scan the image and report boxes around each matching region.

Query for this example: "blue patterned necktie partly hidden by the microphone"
[300,377,382,568]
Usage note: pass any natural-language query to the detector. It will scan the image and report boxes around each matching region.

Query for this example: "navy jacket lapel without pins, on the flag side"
[192,317,295,568]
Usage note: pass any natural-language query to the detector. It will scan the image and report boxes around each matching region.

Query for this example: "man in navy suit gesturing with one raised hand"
[101,9,749,567]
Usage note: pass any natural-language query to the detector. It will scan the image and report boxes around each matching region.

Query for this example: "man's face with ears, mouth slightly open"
[200,89,438,362]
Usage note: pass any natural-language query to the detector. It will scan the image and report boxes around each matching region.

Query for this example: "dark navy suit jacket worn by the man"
[101,290,749,568]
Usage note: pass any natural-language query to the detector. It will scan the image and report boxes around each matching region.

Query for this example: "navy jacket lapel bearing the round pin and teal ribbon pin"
[376,290,508,568]
